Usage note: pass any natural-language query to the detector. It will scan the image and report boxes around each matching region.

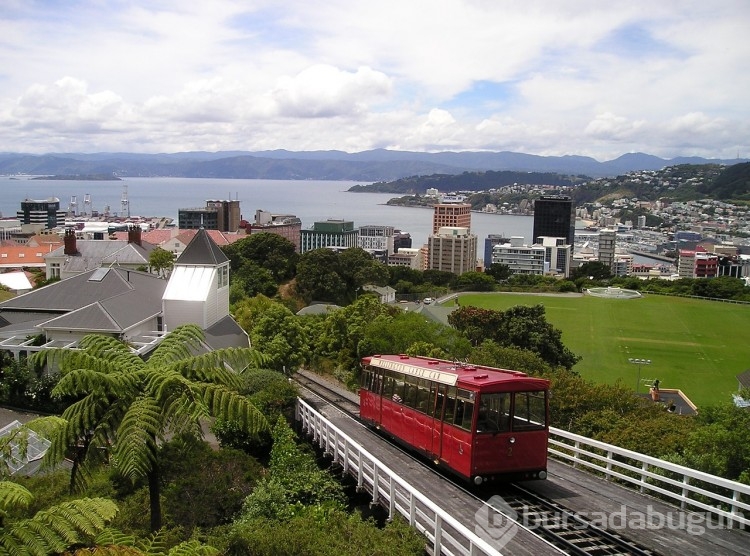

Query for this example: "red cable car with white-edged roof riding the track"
[359,355,549,485]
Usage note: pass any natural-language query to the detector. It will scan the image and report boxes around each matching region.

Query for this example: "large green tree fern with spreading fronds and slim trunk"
[35,324,268,531]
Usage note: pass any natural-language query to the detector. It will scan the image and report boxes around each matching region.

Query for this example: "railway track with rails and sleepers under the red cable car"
[293,371,658,556]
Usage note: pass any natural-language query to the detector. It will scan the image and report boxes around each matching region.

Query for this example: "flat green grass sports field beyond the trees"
[460,293,750,406]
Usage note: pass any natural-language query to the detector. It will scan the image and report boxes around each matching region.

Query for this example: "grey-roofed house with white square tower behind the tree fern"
[0,231,249,357]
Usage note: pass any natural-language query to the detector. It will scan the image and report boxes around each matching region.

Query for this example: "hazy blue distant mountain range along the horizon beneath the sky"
[0,149,747,182]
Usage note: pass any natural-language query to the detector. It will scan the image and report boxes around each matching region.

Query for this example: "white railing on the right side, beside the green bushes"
[549,427,750,527]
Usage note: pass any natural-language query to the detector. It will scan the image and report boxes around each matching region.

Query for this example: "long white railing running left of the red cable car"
[297,399,501,556]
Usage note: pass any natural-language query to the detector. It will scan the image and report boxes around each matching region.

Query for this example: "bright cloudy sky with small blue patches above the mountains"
[0,0,750,160]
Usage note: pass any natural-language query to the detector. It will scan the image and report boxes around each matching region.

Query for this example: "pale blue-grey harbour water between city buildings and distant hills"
[0,176,534,259]
